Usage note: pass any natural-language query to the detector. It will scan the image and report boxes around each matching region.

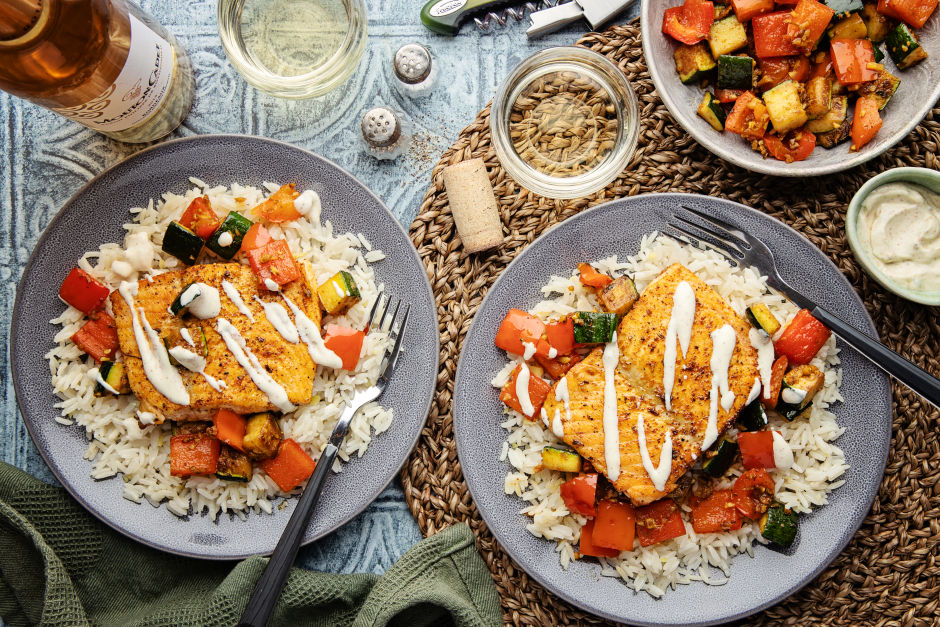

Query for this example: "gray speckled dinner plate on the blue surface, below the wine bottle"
[10,135,440,559]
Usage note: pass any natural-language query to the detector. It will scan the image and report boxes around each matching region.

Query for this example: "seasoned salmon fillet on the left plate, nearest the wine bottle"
[111,262,321,423]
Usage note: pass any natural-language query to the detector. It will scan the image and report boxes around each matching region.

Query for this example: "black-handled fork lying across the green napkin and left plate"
[238,294,411,627]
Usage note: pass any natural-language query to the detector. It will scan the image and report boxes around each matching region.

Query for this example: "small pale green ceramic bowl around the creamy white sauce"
[845,168,940,306]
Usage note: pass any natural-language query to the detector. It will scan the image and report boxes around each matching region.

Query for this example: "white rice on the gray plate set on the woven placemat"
[493,233,849,597]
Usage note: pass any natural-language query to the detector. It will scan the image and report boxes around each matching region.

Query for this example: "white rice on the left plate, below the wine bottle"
[46,178,394,518]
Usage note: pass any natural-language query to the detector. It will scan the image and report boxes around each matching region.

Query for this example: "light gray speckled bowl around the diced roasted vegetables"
[640,0,940,176]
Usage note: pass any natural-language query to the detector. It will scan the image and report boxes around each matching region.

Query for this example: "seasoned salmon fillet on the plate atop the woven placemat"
[544,264,759,506]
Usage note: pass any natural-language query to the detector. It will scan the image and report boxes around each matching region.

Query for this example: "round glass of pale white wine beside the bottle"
[218,0,368,99]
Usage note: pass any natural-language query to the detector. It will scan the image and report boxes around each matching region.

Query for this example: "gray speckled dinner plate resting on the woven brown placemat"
[454,194,892,626]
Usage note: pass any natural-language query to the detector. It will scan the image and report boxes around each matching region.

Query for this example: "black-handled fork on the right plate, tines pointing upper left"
[664,206,940,408]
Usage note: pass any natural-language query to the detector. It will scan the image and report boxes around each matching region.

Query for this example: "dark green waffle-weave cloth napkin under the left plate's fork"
[0,463,502,627]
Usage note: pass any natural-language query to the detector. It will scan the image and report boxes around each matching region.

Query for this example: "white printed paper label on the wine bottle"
[53,15,174,131]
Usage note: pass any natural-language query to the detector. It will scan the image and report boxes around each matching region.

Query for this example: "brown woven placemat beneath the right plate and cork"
[402,22,940,627]
